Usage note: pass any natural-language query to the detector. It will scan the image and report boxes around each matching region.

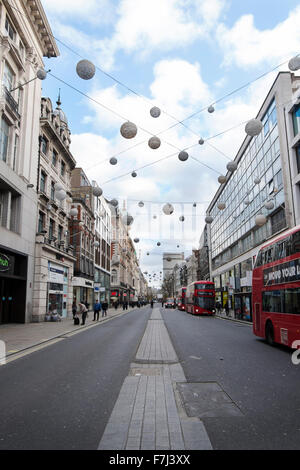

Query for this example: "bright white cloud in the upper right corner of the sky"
[216,6,300,68]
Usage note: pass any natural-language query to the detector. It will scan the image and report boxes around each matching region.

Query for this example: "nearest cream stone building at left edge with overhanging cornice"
[0,0,59,323]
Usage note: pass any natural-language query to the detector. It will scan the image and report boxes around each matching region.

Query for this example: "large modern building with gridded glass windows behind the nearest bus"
[208,72,300,320]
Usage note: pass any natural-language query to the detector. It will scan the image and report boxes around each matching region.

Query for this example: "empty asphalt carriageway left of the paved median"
[0,307,151,450]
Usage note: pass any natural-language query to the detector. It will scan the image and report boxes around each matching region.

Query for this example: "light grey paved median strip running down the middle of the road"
[98,308,212,450]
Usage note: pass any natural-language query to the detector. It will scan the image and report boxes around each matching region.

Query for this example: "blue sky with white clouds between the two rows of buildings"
[42,0,300,286]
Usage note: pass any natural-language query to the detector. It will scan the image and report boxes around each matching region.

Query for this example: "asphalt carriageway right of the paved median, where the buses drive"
[161,309,300,450]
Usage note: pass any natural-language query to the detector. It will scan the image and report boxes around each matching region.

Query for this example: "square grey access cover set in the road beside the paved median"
[177,382,243,418]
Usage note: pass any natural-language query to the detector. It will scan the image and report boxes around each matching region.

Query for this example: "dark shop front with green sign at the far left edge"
[0,247,27,324]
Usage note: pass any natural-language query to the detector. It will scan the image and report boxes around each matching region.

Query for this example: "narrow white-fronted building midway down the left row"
[92,181,112,302]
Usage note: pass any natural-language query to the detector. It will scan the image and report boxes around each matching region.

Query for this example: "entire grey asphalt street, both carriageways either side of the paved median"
[0,304,300,449]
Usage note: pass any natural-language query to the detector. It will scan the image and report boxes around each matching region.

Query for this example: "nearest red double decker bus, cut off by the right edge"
[252,225,300,347]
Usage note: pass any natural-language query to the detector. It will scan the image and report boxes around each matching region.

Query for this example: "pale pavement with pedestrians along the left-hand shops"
[0,307,136,356]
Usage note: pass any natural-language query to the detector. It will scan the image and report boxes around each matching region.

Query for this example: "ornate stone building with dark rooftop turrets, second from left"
[32,97,76,321]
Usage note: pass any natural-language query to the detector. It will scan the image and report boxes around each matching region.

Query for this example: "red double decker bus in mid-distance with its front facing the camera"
[185,281,216,315]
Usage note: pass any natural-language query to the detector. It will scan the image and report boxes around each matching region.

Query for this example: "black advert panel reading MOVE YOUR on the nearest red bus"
[263,258,300,286]
